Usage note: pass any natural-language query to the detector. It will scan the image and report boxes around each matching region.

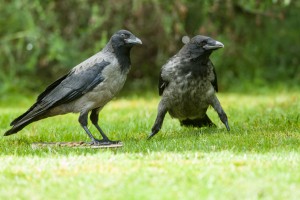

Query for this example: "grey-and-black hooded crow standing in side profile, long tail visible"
[4,30,142,145]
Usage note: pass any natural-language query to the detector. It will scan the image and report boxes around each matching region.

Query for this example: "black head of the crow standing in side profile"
[111,30,142,49]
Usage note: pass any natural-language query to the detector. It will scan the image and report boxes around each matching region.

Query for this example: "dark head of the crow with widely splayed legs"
[181,35,224,58]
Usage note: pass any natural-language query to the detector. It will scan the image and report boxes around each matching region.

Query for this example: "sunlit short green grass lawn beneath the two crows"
[0,91,300,199]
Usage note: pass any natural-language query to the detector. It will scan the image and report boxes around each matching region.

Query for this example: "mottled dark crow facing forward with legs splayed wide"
[149,35,230,138]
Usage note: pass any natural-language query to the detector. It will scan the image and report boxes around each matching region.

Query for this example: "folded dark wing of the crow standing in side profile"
[11,60,110,125]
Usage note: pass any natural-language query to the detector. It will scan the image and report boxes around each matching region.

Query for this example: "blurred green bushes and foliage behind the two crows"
[0,0,300,95]
